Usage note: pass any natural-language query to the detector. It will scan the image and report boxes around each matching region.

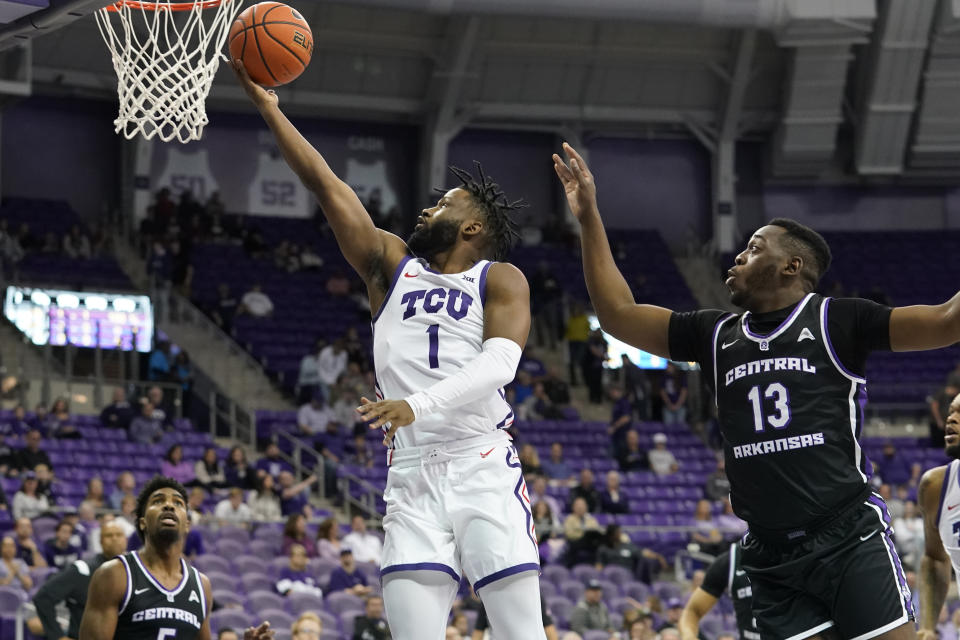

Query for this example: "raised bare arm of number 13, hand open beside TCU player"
[553,143,672,358]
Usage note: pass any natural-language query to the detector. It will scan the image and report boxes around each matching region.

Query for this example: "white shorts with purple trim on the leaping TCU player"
[381,431,540,590]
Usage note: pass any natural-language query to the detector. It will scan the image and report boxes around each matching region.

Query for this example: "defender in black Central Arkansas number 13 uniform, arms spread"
[554,145,960,640]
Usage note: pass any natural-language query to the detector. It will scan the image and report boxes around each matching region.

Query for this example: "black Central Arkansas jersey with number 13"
[671,293,889,539]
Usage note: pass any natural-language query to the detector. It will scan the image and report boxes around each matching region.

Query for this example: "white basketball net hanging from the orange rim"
[96,0,243,142]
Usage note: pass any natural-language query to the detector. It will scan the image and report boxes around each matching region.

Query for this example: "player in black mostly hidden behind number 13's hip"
[677,542,760,640]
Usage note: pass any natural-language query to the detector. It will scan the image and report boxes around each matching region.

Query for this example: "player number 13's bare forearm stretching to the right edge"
[890,293,960,351]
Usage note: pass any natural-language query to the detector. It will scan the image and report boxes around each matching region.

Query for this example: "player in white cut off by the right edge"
[917,395,960,640]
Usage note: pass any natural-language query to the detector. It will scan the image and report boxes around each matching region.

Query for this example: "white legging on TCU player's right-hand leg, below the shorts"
[477,571,547,640]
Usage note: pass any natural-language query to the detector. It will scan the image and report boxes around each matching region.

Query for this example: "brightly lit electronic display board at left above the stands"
[3,287,153,353]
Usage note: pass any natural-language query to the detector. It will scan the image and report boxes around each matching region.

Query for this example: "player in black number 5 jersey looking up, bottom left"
[79,476,273,640]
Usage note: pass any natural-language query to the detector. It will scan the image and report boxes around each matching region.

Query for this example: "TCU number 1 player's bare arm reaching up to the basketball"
[233,60,407,292]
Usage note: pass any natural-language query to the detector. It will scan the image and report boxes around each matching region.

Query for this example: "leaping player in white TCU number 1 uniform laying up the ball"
[234,62,545,640]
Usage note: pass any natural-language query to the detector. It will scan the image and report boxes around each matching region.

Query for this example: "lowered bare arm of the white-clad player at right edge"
[917,467,950,640]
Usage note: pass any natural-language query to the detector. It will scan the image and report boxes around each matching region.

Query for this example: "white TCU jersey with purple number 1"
[373,257,513,449]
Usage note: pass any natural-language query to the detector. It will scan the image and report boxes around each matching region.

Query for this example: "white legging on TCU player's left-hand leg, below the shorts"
[383,571,460,640]
